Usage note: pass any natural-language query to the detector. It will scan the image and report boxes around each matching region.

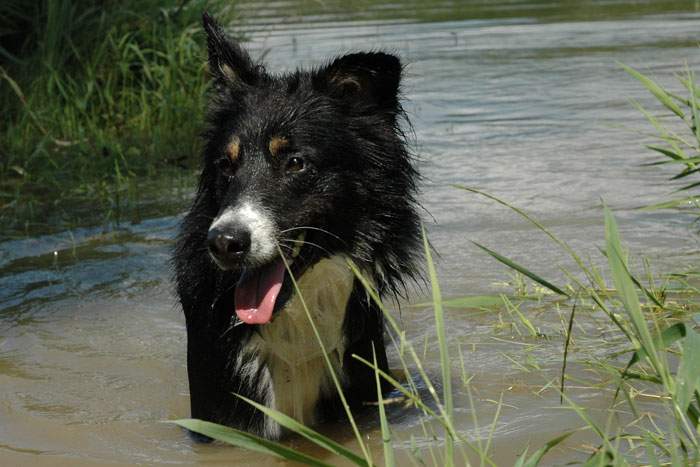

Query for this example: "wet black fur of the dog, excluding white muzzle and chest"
[174,14,421,433]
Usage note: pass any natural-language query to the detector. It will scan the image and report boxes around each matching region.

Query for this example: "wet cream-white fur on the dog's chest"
[239,256,354,438]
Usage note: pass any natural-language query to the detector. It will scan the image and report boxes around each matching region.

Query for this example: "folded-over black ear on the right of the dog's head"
[314,52,401,111]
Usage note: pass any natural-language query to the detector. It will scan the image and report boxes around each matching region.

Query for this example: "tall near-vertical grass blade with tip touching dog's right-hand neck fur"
[421,226,454,466]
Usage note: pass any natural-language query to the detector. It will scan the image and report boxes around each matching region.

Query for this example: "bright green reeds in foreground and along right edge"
[176,68,700,467]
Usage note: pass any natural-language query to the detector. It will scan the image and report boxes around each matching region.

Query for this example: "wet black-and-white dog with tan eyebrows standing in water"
[173,13,422,439]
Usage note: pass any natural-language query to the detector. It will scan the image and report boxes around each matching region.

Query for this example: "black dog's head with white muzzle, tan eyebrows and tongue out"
[194,14,418,324]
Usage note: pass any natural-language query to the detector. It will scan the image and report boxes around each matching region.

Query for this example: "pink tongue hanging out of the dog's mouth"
[235,260,285,324]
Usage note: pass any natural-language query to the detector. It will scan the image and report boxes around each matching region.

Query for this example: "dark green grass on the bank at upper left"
[0,0,233,238]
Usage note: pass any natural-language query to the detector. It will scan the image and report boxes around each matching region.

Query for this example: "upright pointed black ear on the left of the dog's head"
[202,12,260,85]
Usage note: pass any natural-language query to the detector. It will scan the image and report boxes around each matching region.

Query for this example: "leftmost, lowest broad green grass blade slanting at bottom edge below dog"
[170,418,330,467]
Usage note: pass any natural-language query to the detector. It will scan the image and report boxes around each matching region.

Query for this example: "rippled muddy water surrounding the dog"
[0,1,700,465]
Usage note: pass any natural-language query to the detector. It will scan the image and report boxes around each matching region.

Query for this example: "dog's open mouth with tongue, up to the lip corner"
[234,236,305,324]
